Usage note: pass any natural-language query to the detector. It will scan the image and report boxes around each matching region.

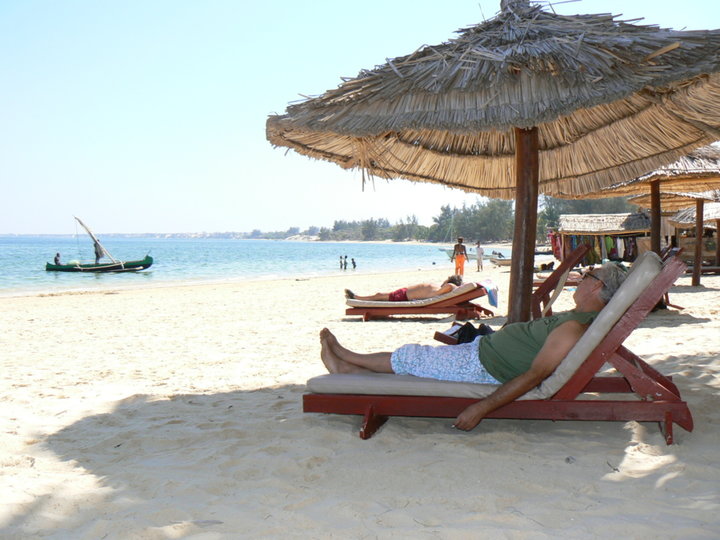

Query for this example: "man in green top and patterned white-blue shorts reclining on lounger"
[320,263,626,430]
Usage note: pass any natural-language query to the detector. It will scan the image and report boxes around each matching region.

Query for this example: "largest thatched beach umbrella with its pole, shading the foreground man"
[267,0,720,321]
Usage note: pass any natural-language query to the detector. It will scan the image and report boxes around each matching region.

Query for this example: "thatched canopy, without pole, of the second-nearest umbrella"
[587,142,720,199]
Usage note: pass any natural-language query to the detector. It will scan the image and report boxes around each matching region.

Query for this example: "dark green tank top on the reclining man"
[480,311,597,383]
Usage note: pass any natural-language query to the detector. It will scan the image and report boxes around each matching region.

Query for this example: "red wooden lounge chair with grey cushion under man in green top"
[303,253,693,444]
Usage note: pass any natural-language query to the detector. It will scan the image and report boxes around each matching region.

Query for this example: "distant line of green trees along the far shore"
[250,196,635,242]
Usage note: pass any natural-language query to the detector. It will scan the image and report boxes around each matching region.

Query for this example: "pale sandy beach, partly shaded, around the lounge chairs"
[0,263,720,539]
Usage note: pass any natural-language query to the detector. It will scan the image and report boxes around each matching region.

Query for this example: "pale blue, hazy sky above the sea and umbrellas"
[0,0,720,234]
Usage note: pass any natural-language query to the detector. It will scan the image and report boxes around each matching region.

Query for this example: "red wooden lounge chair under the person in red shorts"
[345,283,494,321]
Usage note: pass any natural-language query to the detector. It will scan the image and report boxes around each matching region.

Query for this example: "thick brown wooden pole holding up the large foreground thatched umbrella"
[508,128,539,323]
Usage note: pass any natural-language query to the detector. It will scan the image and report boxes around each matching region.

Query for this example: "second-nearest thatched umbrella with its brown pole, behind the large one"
[586,143,720,253]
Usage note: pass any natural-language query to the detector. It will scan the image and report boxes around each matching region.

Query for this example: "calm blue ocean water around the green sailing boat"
[0,235,509,296]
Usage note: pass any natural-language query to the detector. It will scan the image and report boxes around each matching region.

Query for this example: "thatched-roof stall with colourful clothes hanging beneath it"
[556,212,650,265]
